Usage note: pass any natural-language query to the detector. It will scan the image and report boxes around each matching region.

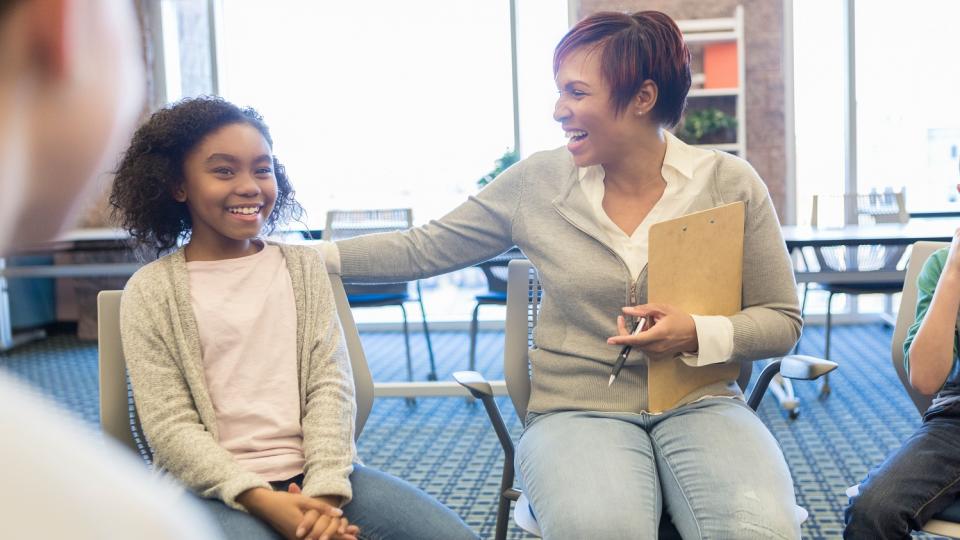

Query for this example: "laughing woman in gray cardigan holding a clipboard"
[328,11,801,538]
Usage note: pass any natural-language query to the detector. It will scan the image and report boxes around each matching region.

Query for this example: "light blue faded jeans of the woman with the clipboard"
[517,398,800,540]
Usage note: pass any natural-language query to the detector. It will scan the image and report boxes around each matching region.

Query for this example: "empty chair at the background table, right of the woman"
[800,191,910,397]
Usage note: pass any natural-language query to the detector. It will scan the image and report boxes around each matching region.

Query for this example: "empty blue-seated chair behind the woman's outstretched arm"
[323,208,437,382]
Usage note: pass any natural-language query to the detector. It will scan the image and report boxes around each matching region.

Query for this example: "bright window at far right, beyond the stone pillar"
[793,0,960,219]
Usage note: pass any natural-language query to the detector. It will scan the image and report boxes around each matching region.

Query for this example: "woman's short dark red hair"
[553,11,690,127]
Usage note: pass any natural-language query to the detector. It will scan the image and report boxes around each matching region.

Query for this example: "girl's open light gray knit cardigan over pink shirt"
[120,244,357,510]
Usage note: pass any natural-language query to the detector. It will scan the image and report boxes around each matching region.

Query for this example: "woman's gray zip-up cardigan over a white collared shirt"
[337,148,801,413]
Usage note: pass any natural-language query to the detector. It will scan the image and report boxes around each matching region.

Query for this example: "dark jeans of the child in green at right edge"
[843,403,960,540]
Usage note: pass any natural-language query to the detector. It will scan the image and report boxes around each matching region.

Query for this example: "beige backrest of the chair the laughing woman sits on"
[503,259,753,423]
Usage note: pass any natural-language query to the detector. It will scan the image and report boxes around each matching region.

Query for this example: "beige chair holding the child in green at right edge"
[847,242,960,538]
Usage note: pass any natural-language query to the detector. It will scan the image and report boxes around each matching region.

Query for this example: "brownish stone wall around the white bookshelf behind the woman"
[577,0,786,221]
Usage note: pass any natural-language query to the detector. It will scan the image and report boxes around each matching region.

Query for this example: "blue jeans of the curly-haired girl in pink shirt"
[196,465,477,540]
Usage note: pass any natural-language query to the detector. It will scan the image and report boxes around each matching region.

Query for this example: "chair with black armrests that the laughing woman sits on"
[453,259,837,540]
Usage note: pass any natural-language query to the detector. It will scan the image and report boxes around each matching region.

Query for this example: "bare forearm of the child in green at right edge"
[910,267,960,394]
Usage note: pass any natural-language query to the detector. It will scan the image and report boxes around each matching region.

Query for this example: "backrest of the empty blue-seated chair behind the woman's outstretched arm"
[323,208,413,296]
